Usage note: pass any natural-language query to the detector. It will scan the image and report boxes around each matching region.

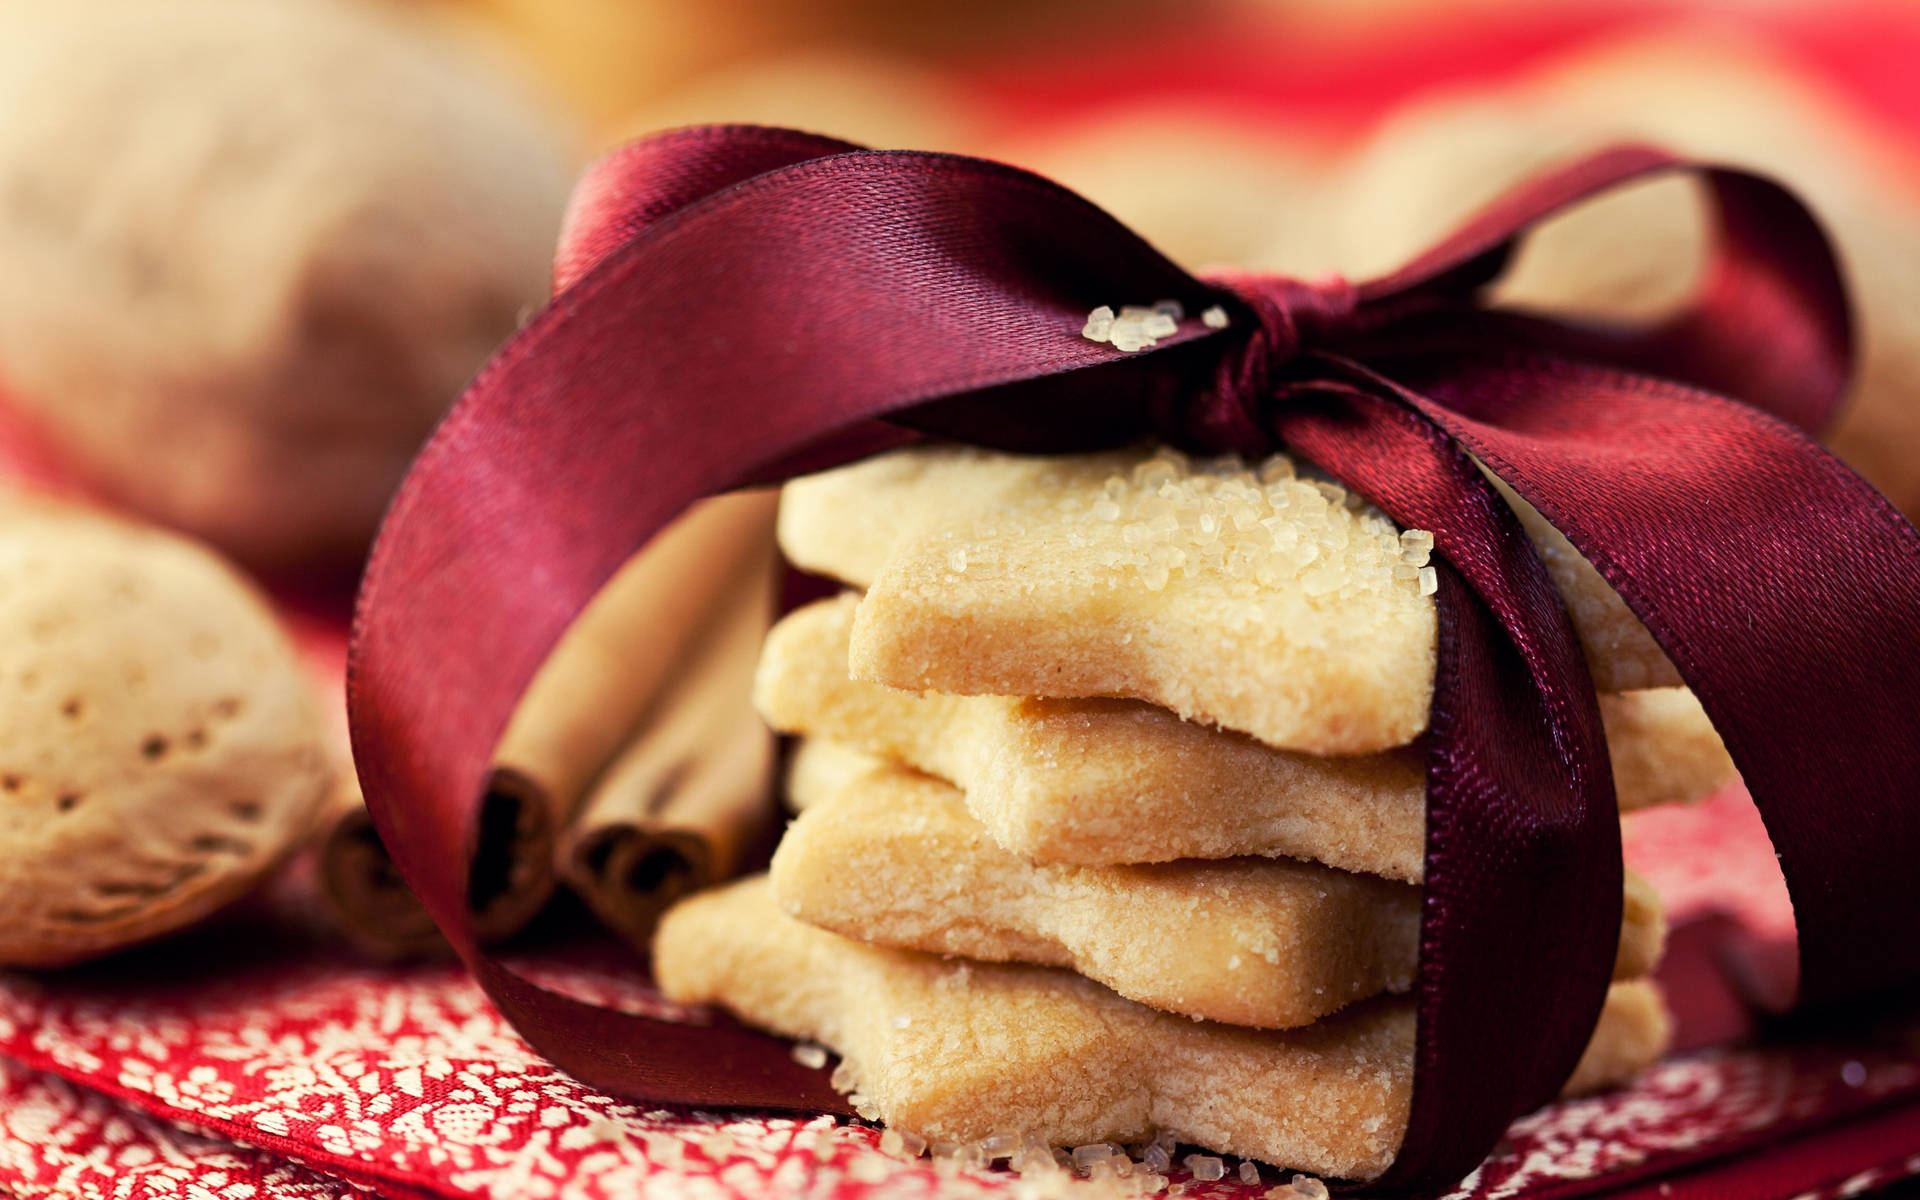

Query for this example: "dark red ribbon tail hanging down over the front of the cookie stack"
[1275,384,1622,1194]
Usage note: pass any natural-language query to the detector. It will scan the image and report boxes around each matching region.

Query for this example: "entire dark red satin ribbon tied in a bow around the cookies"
[349,127,1920,1192]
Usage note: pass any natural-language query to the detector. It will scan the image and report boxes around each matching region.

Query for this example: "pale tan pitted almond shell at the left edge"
[0,505,332,966]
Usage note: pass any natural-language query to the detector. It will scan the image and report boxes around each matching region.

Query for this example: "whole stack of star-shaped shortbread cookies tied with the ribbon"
[655,447,1732,1179]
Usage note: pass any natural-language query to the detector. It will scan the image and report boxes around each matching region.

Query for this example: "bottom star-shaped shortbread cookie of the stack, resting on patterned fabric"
[653,877,1667,1179]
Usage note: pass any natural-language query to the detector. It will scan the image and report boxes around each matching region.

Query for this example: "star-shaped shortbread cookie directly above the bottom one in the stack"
[772,768,1663,1029]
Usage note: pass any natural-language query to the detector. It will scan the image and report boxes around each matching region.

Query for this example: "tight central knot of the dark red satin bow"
[1164,271,1359,459]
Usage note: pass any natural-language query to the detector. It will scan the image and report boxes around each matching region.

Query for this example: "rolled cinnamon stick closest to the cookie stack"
[559,543,774,947]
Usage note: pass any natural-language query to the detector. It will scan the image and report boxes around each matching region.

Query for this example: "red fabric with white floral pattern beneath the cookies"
[0,775,1920,1200]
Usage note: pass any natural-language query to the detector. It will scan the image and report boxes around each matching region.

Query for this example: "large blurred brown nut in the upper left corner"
[0,0,574,568]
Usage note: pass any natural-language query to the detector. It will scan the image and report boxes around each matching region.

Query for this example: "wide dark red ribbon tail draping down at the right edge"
[1374,357,1920,1008]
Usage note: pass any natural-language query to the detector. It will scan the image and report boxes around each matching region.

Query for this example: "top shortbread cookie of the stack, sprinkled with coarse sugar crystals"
[781,447,1678,755]
